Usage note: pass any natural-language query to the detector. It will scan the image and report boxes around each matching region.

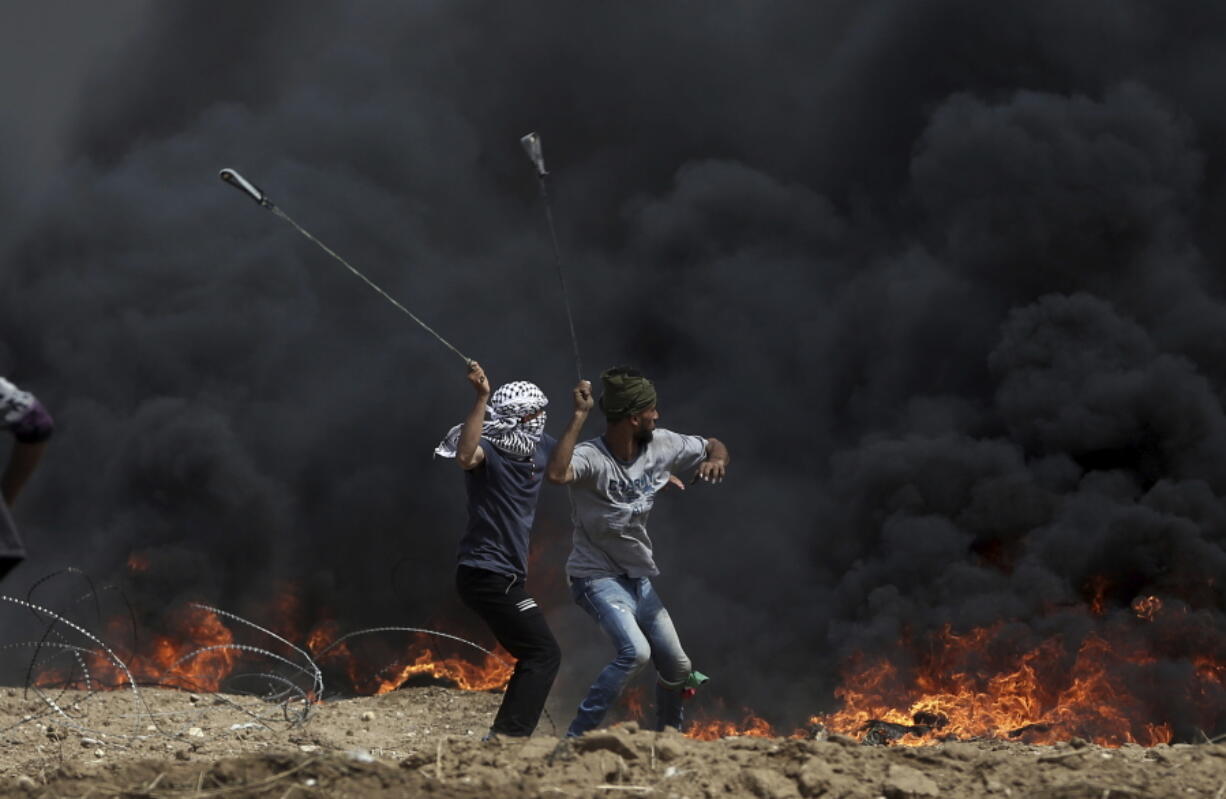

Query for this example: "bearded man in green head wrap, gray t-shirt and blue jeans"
[547,366,728,737]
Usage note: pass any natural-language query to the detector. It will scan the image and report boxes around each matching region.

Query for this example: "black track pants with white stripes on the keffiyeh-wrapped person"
[456,566,562,735]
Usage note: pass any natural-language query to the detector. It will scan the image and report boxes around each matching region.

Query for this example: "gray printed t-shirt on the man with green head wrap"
[566,428,706,577]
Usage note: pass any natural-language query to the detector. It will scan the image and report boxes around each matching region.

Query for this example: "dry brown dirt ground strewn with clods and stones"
[0,686,1226,799]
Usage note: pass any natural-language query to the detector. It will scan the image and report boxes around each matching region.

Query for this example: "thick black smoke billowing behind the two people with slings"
[7,0,1226,734]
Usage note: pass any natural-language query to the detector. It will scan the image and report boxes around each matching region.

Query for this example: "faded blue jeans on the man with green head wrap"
[566,577,690,737]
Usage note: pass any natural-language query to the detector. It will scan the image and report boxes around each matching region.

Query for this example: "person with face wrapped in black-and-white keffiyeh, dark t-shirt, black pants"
[435,362,562,739]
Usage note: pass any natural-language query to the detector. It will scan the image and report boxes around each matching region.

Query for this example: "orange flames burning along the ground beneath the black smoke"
[47,563,1226,745]
